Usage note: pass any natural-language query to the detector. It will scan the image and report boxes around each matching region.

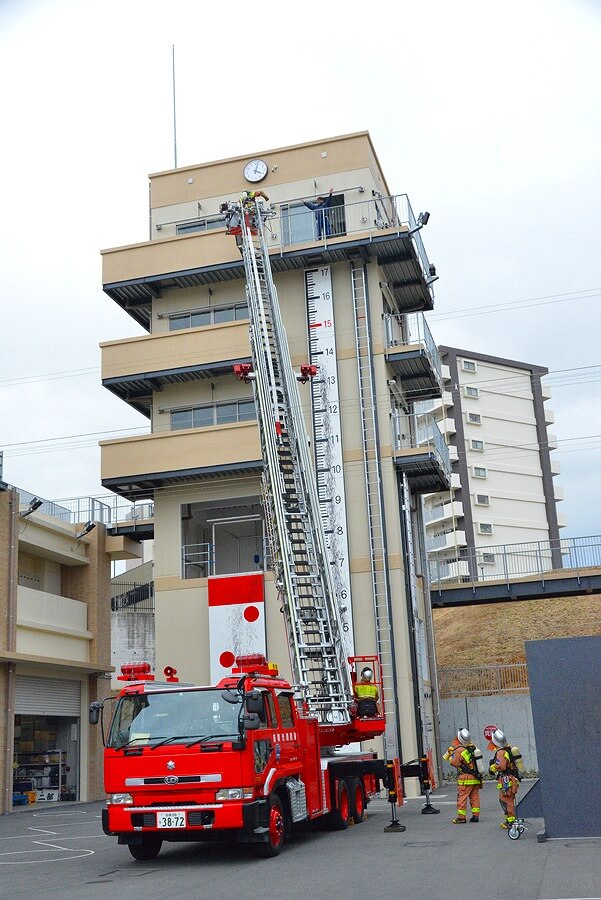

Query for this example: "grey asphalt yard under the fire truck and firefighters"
[0,784,601,900]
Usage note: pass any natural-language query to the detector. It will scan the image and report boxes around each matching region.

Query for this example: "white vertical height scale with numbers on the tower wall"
[305,266,354,656]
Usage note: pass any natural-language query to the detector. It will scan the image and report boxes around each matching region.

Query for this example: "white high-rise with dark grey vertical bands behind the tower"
[420,346,565,581]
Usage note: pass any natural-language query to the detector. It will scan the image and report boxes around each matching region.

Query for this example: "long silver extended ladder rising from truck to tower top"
[234,205,384,744]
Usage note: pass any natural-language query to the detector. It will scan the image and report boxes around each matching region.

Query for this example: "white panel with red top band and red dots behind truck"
[209,572,266,684]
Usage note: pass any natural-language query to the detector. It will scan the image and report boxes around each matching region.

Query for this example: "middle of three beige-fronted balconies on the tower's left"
[100,320,250,417]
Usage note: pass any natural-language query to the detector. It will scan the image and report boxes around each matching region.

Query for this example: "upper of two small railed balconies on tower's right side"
[383,313,442,401]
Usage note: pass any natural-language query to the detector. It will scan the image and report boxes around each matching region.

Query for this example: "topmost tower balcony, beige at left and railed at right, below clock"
[102,194,435,330]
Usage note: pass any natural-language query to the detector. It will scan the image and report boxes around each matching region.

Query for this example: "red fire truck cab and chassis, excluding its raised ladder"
[96,655,385,860]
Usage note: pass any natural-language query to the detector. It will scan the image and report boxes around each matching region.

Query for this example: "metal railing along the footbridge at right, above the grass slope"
[429,536,601,587]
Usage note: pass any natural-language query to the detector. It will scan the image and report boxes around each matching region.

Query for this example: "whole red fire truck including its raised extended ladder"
[90,201,431,860]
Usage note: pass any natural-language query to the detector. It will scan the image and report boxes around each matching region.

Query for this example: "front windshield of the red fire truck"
[107,690,240,749]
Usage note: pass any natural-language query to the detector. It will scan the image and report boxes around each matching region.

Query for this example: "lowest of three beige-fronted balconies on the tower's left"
[100,421,263,500]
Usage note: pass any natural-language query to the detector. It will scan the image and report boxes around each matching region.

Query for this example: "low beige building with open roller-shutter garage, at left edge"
[0,481,132,813]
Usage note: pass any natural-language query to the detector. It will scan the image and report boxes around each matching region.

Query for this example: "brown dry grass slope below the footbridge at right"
[433,594,601,668]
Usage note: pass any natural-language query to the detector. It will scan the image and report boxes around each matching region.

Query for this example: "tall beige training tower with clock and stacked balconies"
[101,132,450,780]
